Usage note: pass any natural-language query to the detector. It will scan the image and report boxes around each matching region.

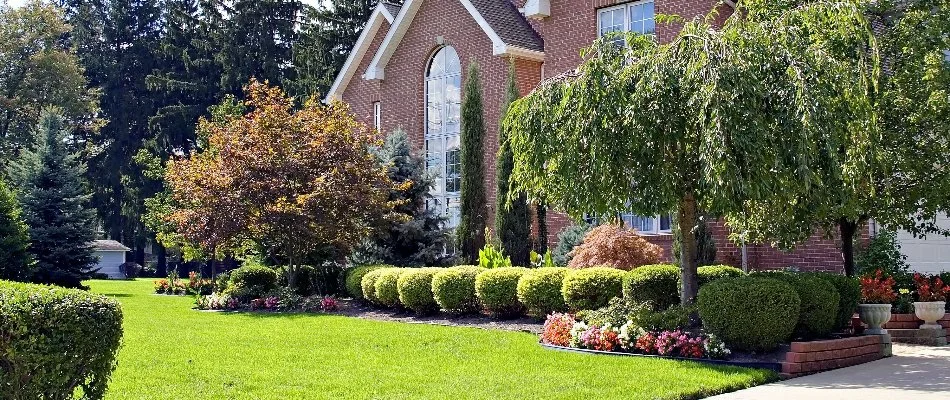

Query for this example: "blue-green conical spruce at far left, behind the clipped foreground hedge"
[10,110,96,288]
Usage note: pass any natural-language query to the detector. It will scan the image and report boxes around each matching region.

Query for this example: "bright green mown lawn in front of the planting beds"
[89,280,773,399]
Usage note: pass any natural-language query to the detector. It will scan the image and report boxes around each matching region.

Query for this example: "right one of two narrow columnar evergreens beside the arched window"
[495,64,531,266]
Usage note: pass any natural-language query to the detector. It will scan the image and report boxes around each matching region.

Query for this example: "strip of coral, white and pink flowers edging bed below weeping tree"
[541,314,731,359]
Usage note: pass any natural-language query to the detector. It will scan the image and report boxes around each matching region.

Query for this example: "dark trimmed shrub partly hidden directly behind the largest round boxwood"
[751,272,839,338]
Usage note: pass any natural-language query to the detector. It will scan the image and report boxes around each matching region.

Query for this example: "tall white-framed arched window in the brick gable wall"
[425,46,462,228]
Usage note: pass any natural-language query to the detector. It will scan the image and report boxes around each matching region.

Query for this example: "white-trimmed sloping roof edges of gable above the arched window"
[363,0,544,80]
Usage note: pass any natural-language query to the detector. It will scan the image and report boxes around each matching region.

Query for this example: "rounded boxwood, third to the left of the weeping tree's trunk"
[518,267,570,317]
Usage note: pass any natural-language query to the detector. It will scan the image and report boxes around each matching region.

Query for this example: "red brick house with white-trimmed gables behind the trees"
[326,0,866,271]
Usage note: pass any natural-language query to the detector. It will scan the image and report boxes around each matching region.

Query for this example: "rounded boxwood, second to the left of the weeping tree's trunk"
[561,267,624,310]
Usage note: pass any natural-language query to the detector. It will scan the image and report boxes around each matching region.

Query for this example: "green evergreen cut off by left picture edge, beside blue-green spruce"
[0,179,33,282]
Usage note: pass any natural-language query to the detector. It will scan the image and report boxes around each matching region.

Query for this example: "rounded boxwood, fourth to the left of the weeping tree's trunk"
[475,267,528,317]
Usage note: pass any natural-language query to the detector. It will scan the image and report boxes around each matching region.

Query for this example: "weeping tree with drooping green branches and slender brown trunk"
[504,1,880,304]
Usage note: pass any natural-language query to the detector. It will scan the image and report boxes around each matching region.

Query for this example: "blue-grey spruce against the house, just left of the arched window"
[357,130,449,266]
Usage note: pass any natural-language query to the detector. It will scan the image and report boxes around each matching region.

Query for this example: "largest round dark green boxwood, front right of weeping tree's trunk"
[696,277,801,351]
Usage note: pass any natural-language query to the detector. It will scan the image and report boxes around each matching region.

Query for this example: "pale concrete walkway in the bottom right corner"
[710,344,950,400]
